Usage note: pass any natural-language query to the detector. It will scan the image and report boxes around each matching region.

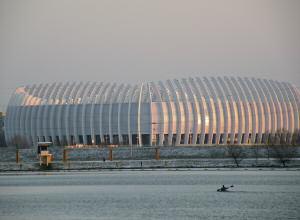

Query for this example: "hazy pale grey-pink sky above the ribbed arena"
[0,0,300,111]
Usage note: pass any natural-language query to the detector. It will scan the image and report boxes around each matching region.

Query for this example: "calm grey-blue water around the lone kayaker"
[0,170,300,220]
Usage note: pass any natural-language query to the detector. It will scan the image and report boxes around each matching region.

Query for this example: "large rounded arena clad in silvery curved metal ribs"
[5,77,300,146]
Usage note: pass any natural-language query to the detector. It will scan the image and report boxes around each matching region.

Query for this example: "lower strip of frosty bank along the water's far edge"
[0,158,300,173]
